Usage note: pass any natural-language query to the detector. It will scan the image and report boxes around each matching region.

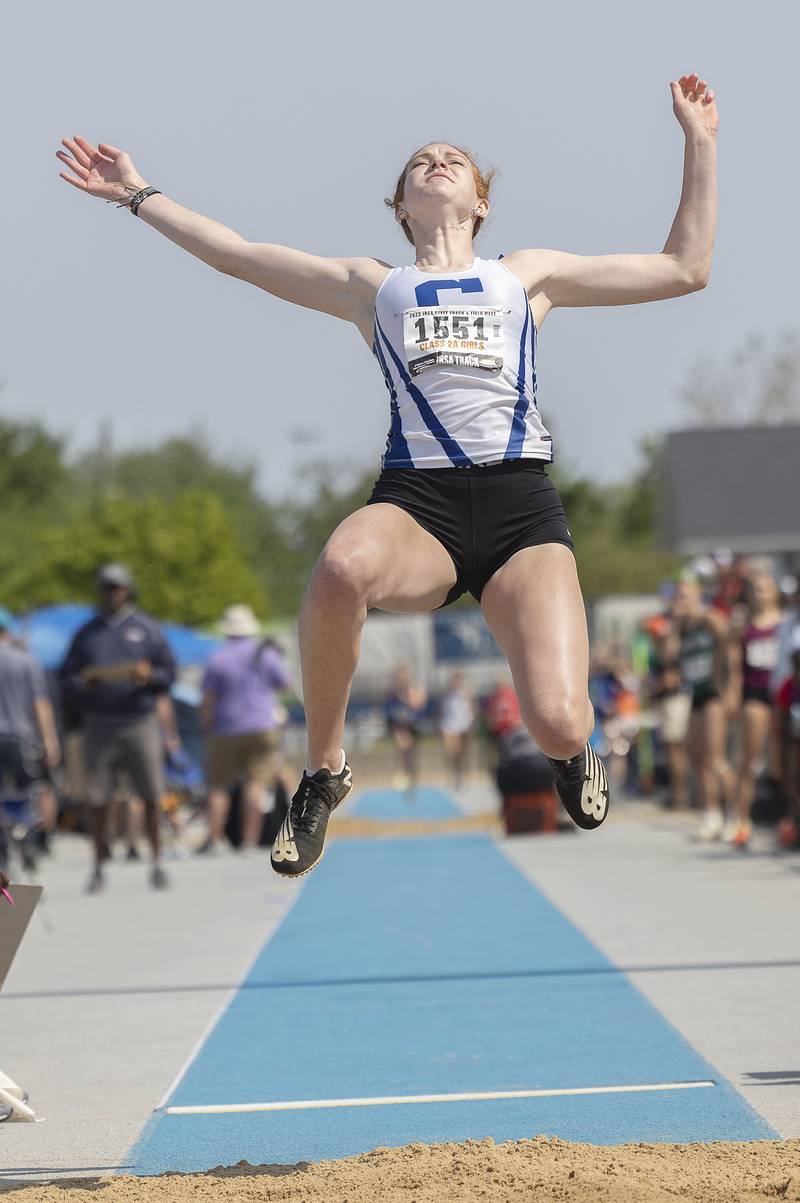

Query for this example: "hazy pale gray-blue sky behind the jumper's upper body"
[6,0,800,494]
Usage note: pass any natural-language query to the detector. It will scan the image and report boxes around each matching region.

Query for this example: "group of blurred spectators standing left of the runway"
[0,564,289,894]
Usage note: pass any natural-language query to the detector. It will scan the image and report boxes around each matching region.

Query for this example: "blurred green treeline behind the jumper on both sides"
[0,413,688,623]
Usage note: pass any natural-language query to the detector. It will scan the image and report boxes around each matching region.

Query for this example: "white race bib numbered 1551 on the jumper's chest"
[403,306,505,377]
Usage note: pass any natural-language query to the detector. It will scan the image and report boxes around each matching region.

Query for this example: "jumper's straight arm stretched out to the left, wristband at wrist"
[57,135,386,322]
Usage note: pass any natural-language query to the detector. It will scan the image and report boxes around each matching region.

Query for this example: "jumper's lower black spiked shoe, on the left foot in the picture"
[269,760,352,877]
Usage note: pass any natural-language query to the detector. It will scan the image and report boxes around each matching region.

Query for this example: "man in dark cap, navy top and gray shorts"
[61,564,176,894]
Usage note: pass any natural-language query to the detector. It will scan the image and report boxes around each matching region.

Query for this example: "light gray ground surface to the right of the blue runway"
[503,804,800,1137]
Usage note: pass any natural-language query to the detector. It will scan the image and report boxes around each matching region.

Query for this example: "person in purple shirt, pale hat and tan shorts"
[200,605,290,852]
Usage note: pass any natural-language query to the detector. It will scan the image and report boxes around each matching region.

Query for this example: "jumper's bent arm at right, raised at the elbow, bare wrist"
[504,75,717,313]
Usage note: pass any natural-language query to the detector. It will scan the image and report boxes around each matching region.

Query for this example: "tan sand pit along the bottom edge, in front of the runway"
[8,1137,800,1203]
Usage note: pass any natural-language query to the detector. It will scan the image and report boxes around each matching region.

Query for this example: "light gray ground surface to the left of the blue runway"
[0,837,298,1185]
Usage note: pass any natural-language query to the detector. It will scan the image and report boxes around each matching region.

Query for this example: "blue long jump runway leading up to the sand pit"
[129,792,776,1174]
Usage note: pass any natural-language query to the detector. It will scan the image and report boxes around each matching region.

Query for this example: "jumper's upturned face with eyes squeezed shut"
[403,143,488,233]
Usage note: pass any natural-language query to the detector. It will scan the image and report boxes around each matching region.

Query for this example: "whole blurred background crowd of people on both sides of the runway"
[0,555,800,893]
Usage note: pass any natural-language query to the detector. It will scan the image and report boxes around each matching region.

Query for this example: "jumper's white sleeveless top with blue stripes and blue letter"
[373,259,552,468]
